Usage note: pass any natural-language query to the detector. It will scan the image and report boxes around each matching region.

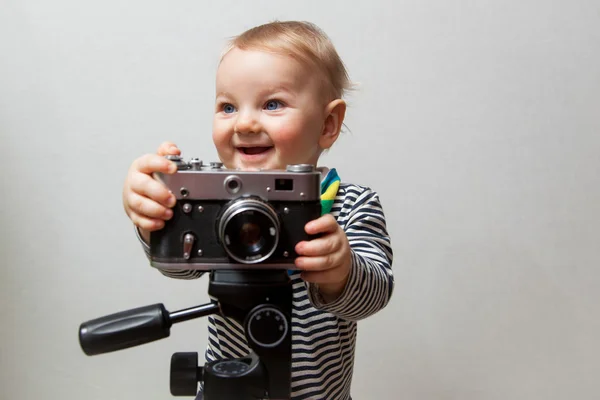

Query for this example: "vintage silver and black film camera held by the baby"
[150,156,321,271]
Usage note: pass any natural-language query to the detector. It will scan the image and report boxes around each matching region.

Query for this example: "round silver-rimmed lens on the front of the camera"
[218,198,279,264]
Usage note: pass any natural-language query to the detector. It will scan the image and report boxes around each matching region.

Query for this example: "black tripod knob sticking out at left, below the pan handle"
[170,353,202,396]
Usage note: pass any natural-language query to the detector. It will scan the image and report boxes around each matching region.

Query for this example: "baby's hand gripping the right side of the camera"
[296,214,352,302]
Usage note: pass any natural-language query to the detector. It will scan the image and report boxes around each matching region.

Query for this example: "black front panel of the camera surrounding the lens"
[150,200,321,270]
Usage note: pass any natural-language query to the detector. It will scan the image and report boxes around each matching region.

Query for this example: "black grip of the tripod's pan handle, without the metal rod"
[79,303,172,356]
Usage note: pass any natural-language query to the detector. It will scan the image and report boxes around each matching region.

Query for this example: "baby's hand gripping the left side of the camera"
[123,142,181,241]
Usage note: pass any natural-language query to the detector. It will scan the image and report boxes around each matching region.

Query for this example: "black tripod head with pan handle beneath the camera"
[79,270,292,400]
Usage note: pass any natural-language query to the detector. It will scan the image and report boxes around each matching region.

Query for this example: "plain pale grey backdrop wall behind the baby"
[0,0,600,400]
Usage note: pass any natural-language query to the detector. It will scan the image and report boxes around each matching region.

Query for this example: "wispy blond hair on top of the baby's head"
[221,21,352,100]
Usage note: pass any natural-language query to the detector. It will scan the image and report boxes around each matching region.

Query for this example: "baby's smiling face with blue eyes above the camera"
[213,48,326,170]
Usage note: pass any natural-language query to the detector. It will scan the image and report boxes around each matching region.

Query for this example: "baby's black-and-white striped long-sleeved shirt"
[136,170,394,400]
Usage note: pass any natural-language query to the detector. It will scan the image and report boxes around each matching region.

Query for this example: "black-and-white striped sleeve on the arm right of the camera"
[308,185,394,321]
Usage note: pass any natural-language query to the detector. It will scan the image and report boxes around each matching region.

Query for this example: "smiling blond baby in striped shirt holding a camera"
[123,21,394,400]
